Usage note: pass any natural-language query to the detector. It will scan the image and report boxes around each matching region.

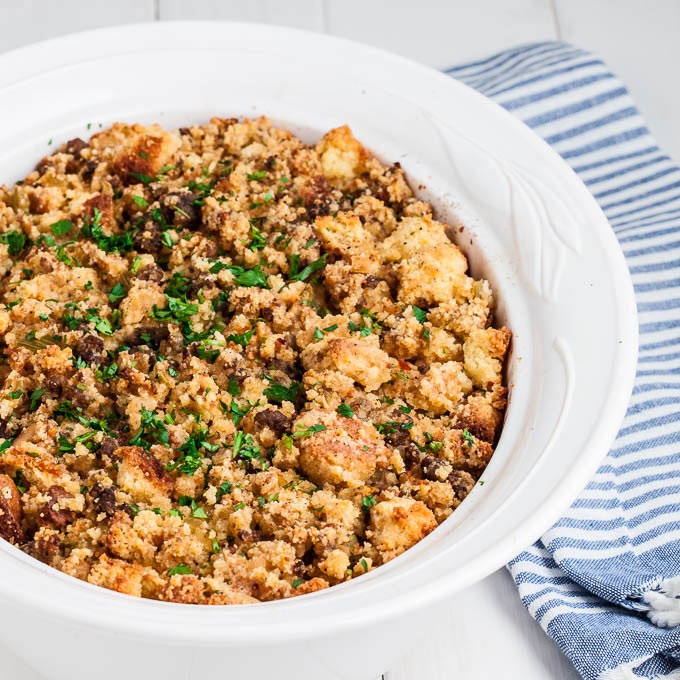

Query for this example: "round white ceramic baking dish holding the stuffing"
[0,22,637,680]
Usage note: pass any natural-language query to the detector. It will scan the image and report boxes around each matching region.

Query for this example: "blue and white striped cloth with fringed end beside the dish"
[446,42,680,680]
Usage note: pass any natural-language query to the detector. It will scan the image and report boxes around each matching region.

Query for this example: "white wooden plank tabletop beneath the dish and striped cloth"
[0,0,680,680]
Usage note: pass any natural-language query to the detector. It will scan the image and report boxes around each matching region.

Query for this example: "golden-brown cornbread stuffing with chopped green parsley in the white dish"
[0,118,510,604]
